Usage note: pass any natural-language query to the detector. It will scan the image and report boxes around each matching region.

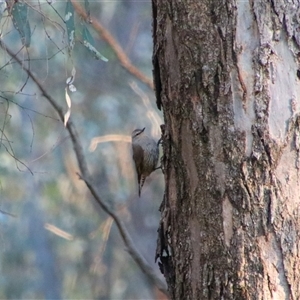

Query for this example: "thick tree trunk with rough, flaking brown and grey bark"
[152,0,300,300]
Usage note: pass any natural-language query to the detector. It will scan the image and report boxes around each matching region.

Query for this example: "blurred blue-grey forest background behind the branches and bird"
[0,0,164,299]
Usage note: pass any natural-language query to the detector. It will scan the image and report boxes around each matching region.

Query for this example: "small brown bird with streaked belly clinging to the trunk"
[131,127,159,196]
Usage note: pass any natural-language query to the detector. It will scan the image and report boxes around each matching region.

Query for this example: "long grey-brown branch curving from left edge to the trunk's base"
[0,40,168,295]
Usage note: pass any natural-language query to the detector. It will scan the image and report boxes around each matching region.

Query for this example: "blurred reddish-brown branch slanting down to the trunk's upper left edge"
[72,0,154,90]
